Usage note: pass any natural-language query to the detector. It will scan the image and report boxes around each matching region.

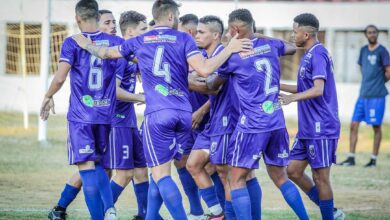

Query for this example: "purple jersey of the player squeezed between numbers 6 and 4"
[112,58,137,128]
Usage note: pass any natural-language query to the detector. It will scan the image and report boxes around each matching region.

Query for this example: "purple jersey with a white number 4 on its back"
[119,27,200,115]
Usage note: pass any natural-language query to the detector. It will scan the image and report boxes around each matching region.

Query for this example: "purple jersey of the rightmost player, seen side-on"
[297,43,340,139]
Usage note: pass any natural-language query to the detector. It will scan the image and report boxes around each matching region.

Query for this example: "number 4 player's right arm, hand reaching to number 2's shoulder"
[187,34,252,77]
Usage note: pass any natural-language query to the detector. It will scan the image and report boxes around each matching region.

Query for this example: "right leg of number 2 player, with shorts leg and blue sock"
[263,128,309,219]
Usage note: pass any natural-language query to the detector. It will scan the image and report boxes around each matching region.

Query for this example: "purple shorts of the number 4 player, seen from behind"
[142,109,192,167]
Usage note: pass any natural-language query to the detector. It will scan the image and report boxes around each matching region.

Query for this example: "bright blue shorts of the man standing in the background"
[352,97,386,125]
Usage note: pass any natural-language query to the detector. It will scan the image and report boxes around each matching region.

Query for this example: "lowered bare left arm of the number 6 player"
[40,62,71,121]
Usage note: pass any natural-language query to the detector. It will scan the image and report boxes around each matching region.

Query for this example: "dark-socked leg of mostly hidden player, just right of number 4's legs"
[174,132,203,217]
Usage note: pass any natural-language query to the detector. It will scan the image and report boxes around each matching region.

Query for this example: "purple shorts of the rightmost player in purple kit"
[289,139,338,169]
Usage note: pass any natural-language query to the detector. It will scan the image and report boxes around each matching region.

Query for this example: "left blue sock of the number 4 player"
[145,175,163,220]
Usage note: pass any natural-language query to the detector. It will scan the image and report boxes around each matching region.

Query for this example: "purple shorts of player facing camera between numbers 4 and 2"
[192,132,231,165]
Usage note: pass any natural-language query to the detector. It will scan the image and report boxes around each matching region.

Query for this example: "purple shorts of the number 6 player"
[68,121,111,165]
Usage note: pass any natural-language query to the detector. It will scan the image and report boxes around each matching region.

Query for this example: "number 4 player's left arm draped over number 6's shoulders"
[72,34,122,59]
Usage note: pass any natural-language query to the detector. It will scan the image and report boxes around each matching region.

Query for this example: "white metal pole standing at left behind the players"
[38,0,51,142]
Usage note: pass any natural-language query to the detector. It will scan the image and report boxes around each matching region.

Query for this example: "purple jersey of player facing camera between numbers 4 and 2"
[205,44,239,136]
